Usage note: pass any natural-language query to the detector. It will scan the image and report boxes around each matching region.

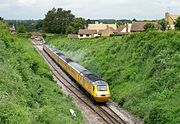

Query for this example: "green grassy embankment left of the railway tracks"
[0,30,83,124]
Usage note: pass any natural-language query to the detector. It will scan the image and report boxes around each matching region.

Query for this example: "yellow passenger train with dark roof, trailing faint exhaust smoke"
[43,44,110,103]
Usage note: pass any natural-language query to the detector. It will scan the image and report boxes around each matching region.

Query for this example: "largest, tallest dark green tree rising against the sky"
[43,8,74,34]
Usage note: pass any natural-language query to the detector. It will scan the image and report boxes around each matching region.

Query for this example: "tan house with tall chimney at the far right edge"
[165,12,180,29]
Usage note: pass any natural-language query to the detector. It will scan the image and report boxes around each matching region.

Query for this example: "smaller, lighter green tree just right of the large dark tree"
[67,18,86,34]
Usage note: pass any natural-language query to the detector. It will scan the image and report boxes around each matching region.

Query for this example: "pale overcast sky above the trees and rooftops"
[0,0,180,19]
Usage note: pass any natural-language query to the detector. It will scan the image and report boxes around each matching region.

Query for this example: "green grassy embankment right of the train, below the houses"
[47,32,180,124]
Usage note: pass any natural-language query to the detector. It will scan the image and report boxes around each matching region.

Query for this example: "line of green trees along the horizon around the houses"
[0,8,180,34]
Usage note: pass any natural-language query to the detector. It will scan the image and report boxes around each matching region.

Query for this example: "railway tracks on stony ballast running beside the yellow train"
[33,40,126,124]
